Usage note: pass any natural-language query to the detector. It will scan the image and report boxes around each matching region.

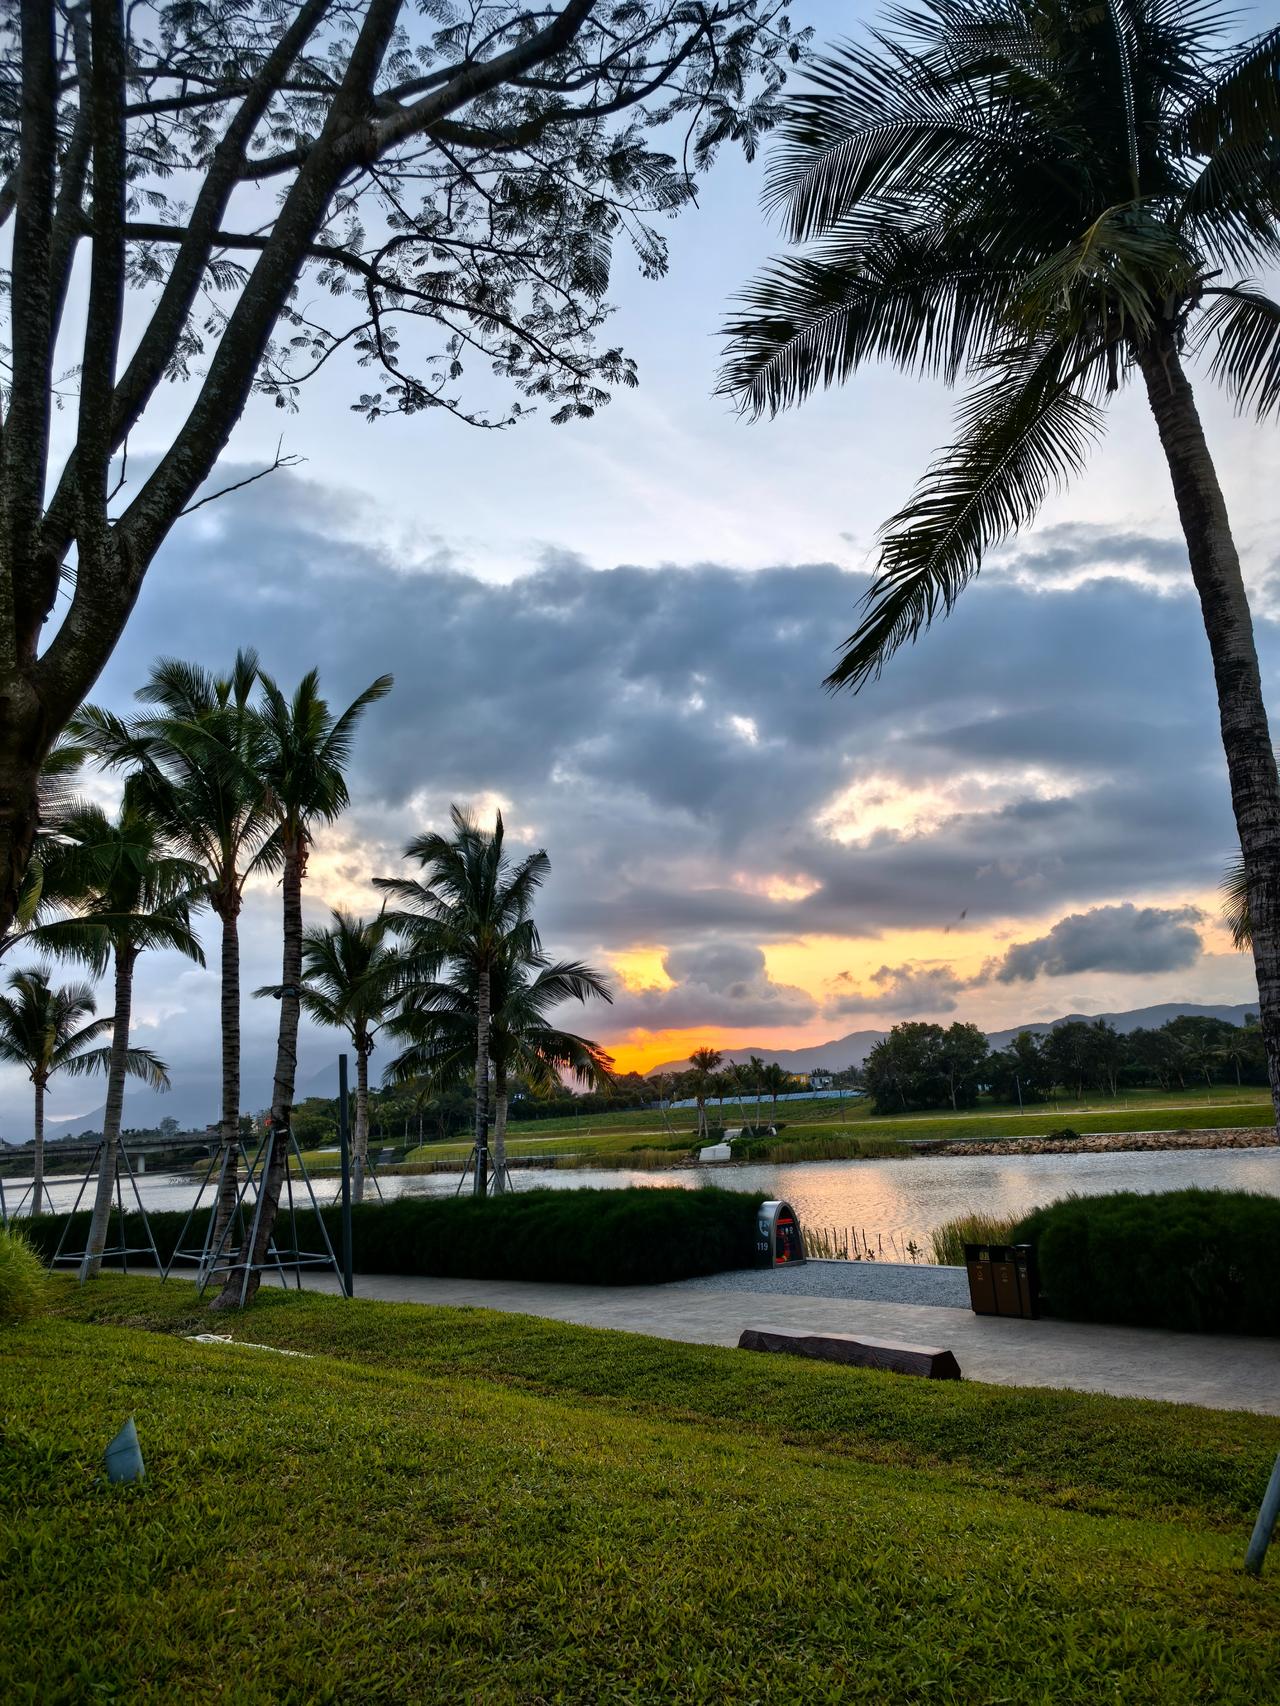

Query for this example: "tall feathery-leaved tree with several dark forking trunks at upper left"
[0,0,799,937]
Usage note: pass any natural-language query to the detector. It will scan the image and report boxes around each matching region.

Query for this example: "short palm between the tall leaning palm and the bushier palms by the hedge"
[254,909,399,1203]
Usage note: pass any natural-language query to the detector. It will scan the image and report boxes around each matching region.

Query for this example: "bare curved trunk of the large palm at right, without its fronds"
[1138,334,1280,1124]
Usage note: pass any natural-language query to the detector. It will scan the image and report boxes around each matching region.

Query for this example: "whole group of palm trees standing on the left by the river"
[0,650,611,1302]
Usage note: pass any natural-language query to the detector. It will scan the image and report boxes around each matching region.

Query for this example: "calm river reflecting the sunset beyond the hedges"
[3,1148,1280,1256]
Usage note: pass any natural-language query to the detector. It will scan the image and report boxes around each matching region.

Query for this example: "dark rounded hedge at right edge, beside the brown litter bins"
[1009,1191,1280,1336]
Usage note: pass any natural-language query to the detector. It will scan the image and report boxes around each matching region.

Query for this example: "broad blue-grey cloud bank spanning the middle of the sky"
[3,476,1277,1126]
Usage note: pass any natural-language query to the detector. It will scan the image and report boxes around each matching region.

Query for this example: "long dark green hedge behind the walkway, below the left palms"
[24,1186,759,1285]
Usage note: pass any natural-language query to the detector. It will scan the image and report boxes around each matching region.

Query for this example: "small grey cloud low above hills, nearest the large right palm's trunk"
[995,901,1205,983]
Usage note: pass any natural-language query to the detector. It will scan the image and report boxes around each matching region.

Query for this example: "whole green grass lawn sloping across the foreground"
[0,1276,1280,1706]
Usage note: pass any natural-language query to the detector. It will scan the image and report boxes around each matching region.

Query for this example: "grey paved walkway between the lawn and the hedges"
[288,1274,1280,1416]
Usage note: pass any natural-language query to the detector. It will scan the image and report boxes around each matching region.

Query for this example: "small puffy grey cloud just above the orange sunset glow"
[609,940,817,1030]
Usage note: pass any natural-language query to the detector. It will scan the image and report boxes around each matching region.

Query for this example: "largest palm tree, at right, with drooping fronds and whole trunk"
[724,0,1280,1132]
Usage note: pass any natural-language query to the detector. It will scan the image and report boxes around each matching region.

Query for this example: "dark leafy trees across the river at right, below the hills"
[862,1013,1268,1114]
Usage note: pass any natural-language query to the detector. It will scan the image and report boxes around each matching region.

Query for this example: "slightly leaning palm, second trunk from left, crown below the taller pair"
[31,788,205,1280]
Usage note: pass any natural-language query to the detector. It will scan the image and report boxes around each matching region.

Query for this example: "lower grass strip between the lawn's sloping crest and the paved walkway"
[40,1274,1280,1529]
